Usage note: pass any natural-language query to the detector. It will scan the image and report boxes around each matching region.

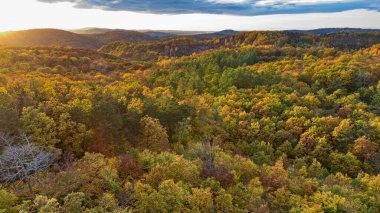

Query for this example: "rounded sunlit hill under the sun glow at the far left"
[0,29,102,49]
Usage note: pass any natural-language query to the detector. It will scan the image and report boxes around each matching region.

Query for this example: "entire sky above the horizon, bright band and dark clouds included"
[0,0,380,31]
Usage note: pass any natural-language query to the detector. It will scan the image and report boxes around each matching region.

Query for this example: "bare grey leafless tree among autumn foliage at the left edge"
[0,133,55,193]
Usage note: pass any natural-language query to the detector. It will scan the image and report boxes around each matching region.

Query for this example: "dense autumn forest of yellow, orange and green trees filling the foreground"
[0,32,380,213]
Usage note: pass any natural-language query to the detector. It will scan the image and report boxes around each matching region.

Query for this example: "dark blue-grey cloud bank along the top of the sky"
[38,0,380,16]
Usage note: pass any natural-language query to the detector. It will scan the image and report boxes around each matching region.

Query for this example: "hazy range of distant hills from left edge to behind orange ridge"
[0,28,236,49]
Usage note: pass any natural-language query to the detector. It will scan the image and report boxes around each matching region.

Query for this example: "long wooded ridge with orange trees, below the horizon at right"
[99,31,380,61]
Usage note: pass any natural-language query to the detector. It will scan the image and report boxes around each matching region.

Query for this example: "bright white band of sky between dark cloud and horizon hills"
[0,0,380,31]
